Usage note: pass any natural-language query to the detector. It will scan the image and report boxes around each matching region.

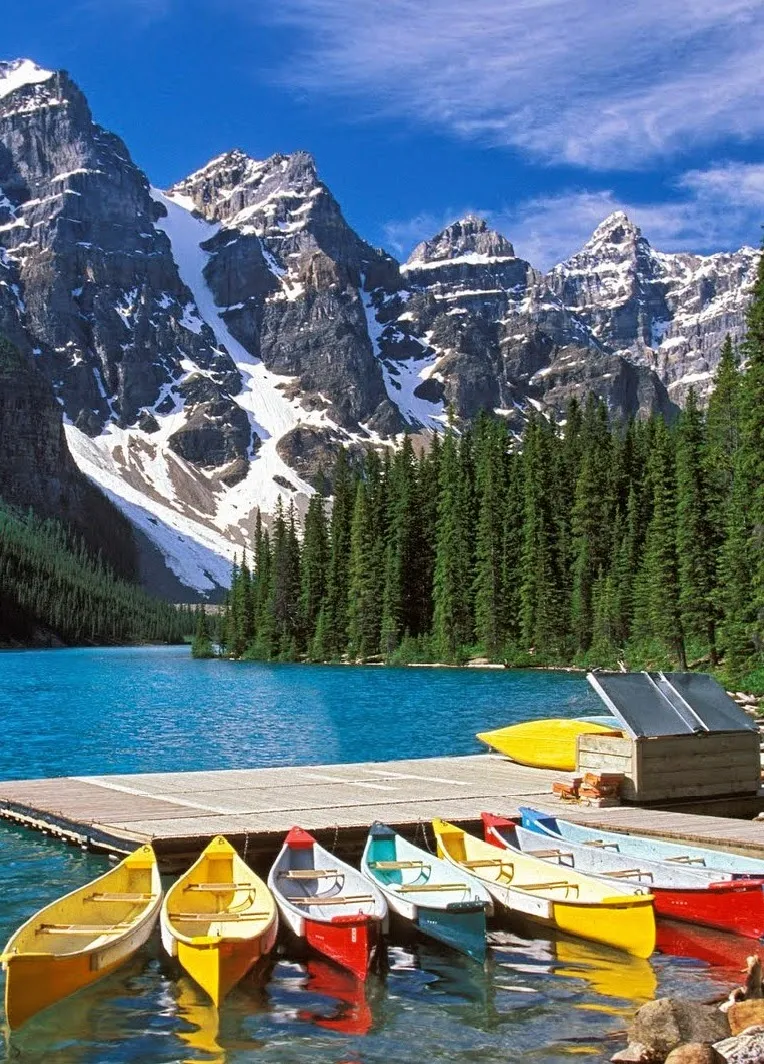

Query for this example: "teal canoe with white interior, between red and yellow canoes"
[361,824,493,962]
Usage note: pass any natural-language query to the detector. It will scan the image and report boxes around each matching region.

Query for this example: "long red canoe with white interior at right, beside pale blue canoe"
[483,811,764,938]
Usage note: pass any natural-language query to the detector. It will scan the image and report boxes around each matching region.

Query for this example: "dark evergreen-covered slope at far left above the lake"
[0,503,194,645]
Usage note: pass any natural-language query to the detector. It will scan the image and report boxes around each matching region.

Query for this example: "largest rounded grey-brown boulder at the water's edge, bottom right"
[629,998,730,1061]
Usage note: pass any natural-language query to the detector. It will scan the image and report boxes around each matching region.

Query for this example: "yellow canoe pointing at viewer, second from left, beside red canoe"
[161,835,279,1005]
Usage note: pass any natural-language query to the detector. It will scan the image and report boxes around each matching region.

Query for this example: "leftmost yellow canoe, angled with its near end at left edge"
[2,846,162,1028]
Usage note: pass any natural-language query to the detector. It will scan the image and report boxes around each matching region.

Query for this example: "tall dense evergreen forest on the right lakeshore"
[212,243,764,688]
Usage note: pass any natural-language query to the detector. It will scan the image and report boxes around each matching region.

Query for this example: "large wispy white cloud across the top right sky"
[261,0,764,169]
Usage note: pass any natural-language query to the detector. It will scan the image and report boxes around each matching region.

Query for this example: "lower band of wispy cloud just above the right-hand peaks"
[385,163,764,269]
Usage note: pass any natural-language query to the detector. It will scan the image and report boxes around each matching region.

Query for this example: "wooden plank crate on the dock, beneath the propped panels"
[577,731,761,802]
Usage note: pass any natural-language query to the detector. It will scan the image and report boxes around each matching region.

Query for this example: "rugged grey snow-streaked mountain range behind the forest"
[0,61,757,594]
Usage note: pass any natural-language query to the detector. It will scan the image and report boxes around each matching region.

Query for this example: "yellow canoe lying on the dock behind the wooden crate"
[477,718,621,772]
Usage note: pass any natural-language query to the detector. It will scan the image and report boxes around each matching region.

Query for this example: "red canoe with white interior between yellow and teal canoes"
[268,828,387,979]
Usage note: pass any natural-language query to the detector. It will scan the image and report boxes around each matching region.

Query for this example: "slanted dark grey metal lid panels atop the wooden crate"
[586,672,757,738]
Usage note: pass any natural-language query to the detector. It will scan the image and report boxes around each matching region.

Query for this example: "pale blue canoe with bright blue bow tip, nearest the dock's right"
[520,809,764,879]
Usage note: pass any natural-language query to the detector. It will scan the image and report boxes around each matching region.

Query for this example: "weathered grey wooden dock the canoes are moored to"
[0,754,764,868]
